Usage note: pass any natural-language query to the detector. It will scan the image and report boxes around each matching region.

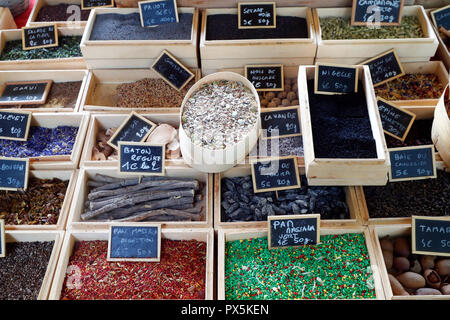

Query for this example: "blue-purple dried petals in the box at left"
[0,126,78,158]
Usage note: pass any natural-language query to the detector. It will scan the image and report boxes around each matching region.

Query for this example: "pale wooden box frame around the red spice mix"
[49,229,214,300]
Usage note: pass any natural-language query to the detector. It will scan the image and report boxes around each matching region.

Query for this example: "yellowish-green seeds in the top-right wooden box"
[320,16,425,40]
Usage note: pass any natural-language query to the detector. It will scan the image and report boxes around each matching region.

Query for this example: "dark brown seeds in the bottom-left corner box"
[0,241,54,300]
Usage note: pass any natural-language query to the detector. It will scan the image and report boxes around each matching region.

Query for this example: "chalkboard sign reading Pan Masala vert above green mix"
[267,214,320,249]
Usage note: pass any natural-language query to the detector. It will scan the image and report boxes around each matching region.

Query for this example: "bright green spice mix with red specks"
[225,233,375,300]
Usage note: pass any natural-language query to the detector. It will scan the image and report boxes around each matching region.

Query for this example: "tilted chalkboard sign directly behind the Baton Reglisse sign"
[108,112,156,150]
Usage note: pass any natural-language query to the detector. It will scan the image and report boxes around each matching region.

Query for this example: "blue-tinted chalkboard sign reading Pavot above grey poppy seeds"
[138,0,178,27]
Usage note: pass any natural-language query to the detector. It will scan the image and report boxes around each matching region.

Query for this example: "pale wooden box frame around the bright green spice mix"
[217,227,385,300]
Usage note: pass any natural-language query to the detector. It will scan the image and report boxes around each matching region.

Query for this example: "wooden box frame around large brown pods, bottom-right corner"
[369,224,450,300]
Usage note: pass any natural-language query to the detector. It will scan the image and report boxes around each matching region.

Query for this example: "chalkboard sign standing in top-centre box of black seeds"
[238,2,277,29]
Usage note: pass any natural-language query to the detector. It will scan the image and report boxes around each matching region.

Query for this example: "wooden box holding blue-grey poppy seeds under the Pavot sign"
[81,8,199,69]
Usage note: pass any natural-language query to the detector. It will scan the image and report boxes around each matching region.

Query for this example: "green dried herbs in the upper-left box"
[0,36,81,61]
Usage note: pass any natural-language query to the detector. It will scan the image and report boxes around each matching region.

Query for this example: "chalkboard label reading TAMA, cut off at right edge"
[411,216,450,257]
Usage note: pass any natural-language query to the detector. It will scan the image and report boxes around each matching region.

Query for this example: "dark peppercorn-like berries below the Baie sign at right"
[364,170,450,218]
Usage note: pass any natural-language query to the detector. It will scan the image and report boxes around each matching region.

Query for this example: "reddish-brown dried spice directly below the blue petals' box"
[0,178,69,225]
